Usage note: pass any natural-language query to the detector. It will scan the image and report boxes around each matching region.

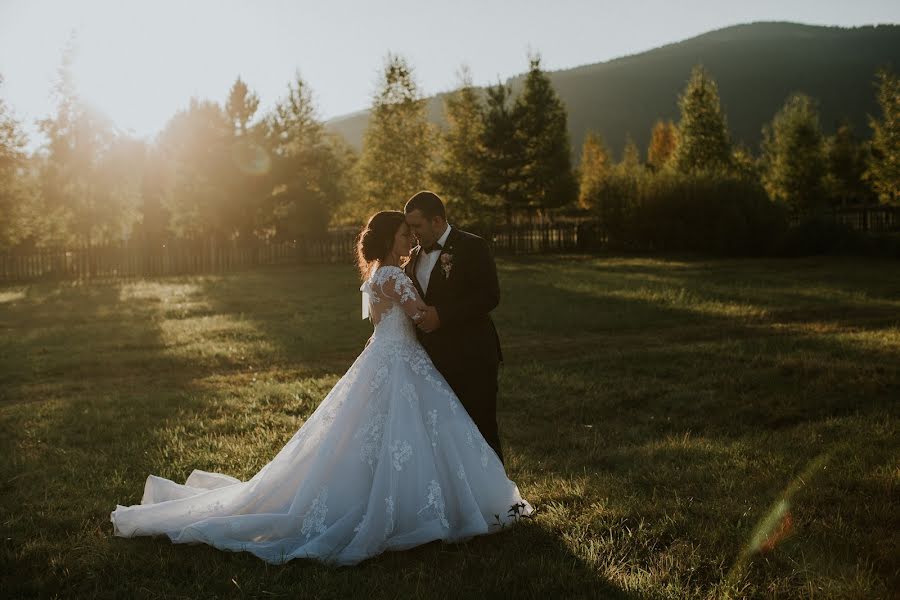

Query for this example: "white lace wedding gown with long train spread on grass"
[110,266,532,565]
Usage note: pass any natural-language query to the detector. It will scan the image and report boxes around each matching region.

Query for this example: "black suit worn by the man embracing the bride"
[406,228,503,462]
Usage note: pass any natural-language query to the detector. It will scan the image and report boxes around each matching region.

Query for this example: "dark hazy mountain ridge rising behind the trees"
[326,21,900,160]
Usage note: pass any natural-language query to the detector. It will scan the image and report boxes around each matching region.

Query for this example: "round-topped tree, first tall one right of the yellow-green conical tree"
[763,94,825,214]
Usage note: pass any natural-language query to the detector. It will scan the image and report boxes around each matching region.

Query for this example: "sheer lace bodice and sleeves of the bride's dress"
[359,265,424,340]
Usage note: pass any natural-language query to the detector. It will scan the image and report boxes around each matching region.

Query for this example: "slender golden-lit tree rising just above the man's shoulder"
[431,67,493,224]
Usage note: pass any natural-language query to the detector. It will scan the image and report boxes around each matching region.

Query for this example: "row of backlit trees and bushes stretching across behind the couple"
[0,45,900,252]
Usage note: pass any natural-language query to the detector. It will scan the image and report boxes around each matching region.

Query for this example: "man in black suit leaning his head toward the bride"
[404,191,503,462]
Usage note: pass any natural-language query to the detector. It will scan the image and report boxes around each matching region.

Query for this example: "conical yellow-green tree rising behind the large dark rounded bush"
[673,66,731,173]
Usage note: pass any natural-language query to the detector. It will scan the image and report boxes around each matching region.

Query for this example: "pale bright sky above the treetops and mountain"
[0,0,900,147]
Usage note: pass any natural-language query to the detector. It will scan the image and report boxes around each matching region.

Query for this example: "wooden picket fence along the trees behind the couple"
[0,223,584,282]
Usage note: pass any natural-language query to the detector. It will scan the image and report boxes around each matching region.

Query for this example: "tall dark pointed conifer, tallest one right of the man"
[513,56,578,216]
